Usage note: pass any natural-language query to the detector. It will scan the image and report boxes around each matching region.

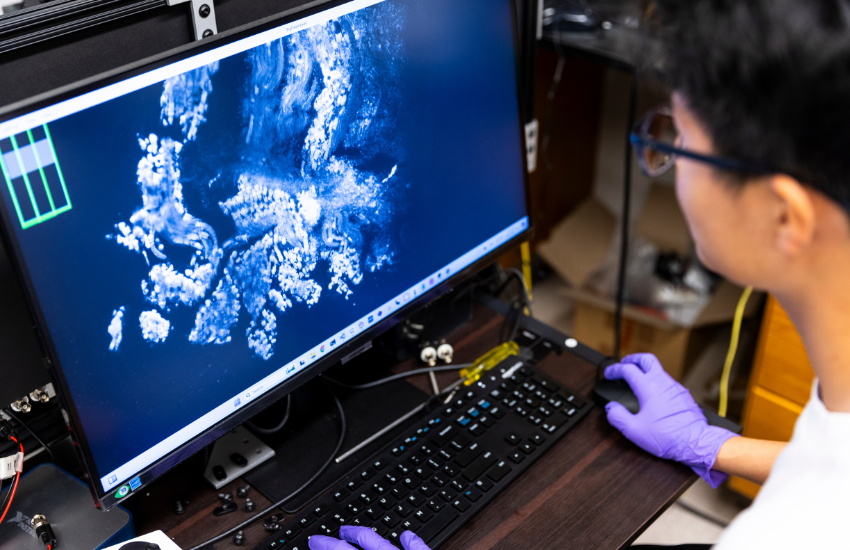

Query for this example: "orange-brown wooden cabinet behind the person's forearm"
[729,296,815,498]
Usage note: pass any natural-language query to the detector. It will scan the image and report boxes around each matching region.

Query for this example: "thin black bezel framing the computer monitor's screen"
[0,0,534,510]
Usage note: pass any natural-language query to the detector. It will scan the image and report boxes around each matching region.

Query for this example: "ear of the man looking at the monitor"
[769,174,816,256]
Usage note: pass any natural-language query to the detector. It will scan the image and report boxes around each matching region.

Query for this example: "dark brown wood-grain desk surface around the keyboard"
[128,307,696,550]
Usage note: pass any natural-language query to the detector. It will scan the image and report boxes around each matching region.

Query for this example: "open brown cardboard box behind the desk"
[538,184,763,380]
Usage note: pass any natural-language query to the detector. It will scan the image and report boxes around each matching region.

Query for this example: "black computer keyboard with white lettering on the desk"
[256,331,592,550]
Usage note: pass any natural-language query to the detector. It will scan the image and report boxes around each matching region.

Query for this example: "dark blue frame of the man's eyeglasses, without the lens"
[629,107,782,178]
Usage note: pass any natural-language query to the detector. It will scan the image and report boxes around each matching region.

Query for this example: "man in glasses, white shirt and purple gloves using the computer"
[310,0,850,550]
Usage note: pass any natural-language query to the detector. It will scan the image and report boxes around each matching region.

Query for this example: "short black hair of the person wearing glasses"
[643,0,850,208]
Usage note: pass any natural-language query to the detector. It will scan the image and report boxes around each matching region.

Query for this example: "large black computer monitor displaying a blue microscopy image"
[0,0,529,508]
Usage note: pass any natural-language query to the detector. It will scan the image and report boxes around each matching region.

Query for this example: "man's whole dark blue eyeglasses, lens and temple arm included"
[630,107,779,178]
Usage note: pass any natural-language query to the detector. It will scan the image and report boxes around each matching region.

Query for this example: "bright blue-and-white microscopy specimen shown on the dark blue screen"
[107,10,403,360]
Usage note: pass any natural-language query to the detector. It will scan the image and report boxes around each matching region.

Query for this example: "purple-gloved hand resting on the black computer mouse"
[605,353,737,487]
